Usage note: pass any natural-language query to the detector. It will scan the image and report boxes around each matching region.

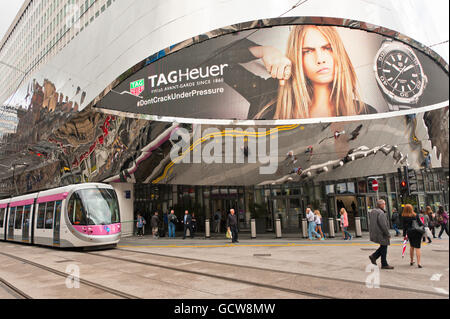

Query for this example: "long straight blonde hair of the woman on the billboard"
[255,25,365,120]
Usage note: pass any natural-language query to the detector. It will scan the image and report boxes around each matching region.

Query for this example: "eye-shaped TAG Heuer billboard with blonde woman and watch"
[96,24,449,124]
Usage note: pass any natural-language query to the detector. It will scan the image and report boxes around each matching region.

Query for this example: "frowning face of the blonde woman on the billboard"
[302,27,334,85]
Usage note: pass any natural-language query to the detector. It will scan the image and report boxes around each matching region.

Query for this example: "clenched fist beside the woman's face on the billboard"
[249,46,292,85]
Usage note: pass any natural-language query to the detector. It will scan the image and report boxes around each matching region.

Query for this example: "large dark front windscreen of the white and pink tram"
[68,189,120,226]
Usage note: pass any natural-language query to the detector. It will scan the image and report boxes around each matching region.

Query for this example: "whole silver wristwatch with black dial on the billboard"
[374,39,428,111]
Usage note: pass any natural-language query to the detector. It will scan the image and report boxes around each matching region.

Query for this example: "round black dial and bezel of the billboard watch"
[376,45,424,102]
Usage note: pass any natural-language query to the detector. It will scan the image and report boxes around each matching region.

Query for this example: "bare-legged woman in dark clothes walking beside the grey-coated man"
[402,204,425,268]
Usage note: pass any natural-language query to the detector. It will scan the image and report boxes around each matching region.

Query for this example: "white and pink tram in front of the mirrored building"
[0,183,121,247]
